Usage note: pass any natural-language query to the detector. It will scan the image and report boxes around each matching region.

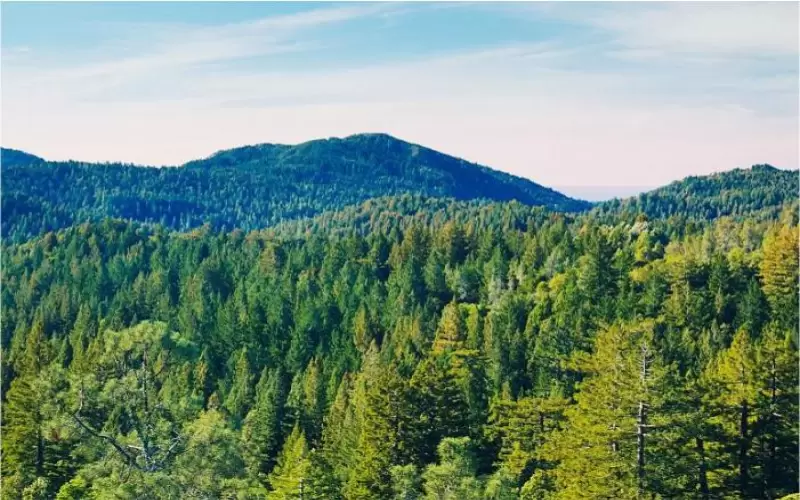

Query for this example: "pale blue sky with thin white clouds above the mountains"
[0,2,800,198]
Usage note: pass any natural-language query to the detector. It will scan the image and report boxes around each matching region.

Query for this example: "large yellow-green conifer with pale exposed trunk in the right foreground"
[545,323,665,499]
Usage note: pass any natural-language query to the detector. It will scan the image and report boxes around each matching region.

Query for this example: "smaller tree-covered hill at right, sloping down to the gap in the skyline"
[593,165,800,220]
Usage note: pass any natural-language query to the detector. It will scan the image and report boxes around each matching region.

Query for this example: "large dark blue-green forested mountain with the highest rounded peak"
[2,134,591,241]
